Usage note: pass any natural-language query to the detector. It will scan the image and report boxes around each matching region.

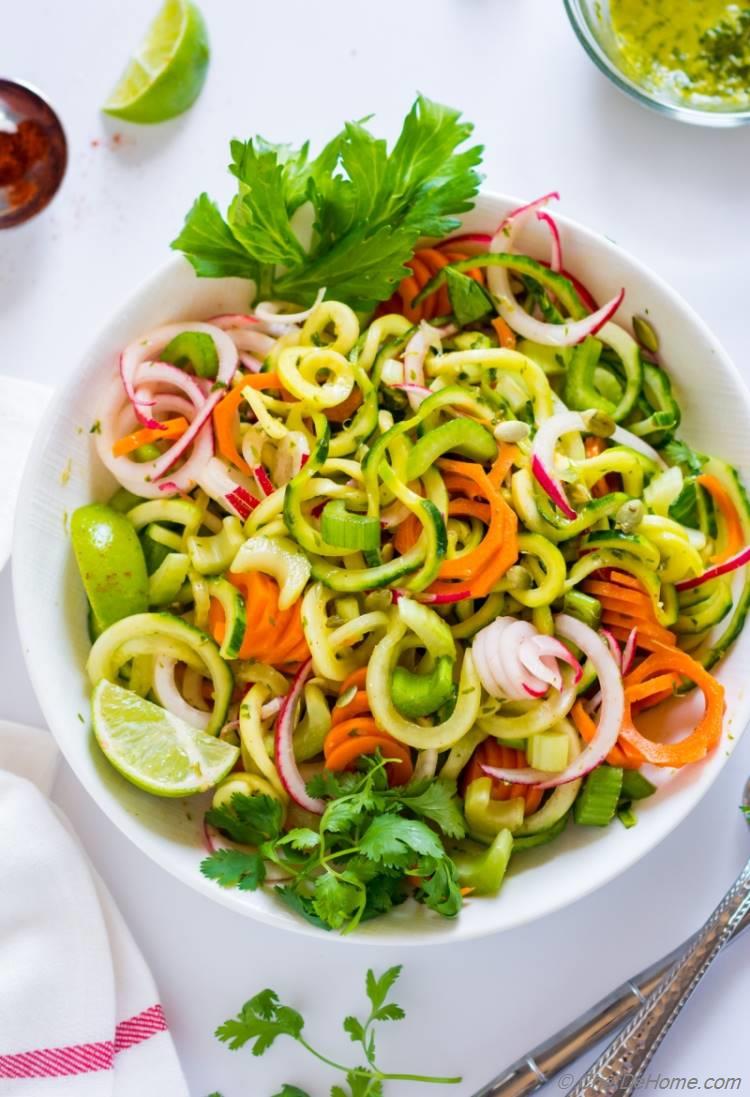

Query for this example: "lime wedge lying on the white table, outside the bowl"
[102,0,208,123]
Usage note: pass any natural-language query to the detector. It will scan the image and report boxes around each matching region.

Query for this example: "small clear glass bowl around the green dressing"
[565,0,750,127]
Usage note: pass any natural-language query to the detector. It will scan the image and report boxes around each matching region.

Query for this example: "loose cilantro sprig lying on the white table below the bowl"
[214,965,462,1097]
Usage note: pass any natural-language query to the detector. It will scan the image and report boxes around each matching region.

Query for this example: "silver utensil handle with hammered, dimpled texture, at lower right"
[568,861,750,1097]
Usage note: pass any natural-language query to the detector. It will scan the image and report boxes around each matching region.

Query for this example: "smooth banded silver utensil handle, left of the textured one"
[474,899,750,1097]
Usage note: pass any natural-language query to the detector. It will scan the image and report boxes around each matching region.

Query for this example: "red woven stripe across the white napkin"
[0,1005,168,1078]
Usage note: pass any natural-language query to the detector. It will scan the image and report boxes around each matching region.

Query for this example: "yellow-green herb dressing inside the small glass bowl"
[610,0,750,106]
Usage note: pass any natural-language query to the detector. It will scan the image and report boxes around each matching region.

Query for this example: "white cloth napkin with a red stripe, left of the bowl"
[0,723,189,1097]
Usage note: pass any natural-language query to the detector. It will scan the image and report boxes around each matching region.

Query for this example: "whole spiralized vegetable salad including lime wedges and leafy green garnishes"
[72,100,750,930]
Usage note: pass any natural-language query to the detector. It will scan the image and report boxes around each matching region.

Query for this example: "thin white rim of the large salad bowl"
[12,188,750,947]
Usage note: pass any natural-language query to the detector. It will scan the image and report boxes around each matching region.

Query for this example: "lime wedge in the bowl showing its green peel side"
[70,502,148,634]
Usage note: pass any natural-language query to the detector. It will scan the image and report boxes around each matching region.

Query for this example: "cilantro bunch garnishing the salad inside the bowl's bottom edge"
[201,755,466,932]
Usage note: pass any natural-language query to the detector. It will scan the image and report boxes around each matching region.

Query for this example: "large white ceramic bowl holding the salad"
[13,194,750,945]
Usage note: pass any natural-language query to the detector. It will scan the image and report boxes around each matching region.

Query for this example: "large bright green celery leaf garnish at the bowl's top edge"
[172,95,482,312]
